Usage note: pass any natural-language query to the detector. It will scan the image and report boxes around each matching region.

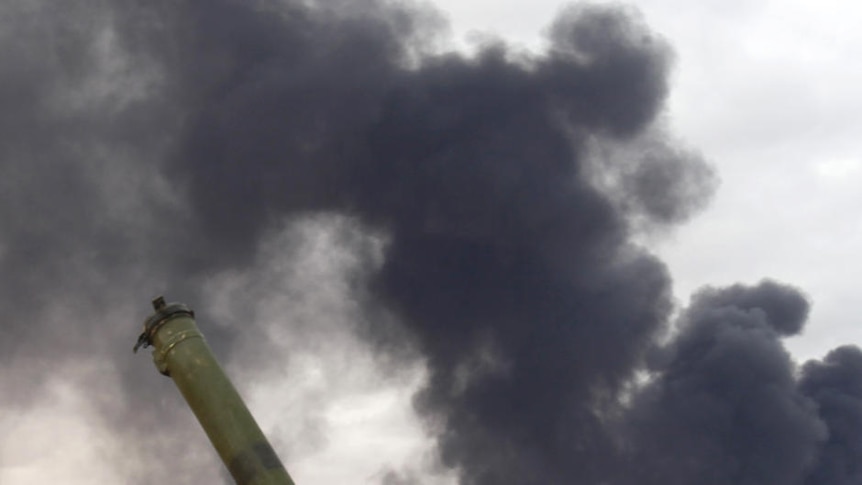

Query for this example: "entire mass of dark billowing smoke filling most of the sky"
[0,0,862,485]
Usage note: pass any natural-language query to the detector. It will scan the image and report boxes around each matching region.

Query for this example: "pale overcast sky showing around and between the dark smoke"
[0,0,862,485]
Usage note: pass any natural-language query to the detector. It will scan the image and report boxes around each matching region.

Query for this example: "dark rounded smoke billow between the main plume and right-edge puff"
[627,281,826,484]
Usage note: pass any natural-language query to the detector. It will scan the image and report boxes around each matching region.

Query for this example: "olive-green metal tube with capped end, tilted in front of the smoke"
[134,297,294,485]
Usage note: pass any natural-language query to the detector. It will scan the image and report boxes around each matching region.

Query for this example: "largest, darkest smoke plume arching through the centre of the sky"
[169,5,704,484]
